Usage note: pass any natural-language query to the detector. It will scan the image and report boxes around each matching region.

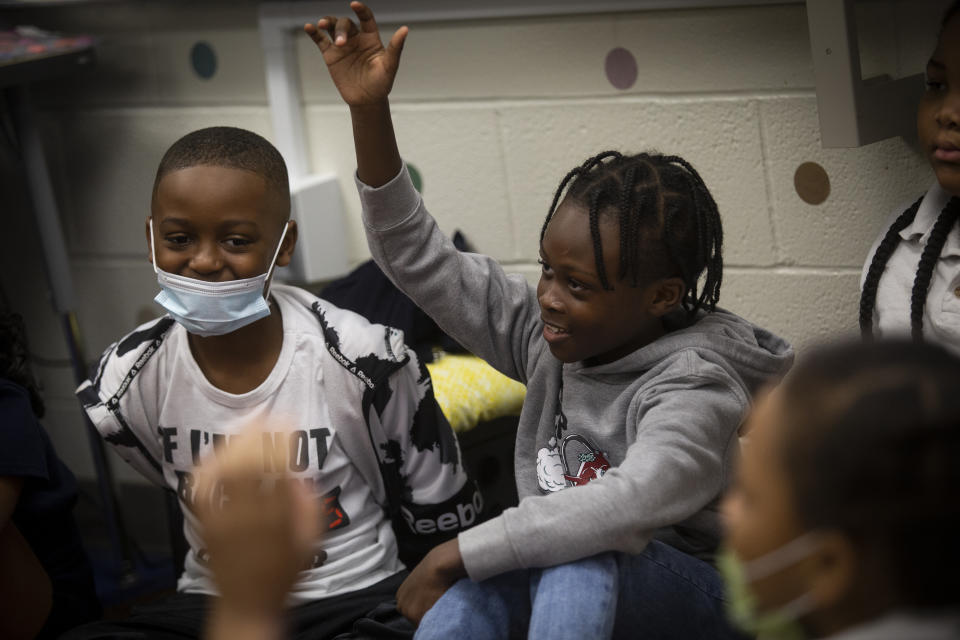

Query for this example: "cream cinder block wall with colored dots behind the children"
[0,0,945,480]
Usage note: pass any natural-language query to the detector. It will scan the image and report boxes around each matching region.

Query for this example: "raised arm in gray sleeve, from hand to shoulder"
[305,2,542,381]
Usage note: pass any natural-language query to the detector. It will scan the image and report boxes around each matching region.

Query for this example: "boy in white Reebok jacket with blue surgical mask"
[65,127,480,638]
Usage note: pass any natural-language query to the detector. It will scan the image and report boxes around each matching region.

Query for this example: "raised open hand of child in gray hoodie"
[303,2,408,107]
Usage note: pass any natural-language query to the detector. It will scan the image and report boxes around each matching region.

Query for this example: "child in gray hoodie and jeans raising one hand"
[305,2,793,638]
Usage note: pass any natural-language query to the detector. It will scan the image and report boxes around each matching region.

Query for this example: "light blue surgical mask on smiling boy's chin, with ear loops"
[150,220,290,336]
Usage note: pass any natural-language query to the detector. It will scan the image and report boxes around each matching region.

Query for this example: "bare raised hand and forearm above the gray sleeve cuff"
[304,2,408,187]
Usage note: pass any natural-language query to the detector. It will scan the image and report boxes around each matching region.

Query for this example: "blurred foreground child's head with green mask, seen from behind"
[719,340,960,640]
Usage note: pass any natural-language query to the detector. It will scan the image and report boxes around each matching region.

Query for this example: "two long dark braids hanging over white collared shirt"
[860,197,960,341]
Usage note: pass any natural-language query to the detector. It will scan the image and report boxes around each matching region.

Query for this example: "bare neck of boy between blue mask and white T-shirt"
[187,301,283,394]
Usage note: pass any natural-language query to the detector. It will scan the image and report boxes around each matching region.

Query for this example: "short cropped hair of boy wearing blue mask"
[153,127,290,214]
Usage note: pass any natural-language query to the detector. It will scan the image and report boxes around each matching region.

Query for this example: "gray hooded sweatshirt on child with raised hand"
[357,167,793,580]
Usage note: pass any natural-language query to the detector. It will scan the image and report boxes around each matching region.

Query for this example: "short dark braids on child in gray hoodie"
[540,151,723,316]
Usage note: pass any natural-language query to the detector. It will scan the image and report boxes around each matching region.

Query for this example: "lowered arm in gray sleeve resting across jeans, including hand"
[397,368,749,621]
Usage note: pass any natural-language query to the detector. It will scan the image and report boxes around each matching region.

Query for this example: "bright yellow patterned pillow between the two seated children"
[427,354,527,432]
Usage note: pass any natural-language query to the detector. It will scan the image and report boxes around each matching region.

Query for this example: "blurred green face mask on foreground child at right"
[717,532,818,640]
